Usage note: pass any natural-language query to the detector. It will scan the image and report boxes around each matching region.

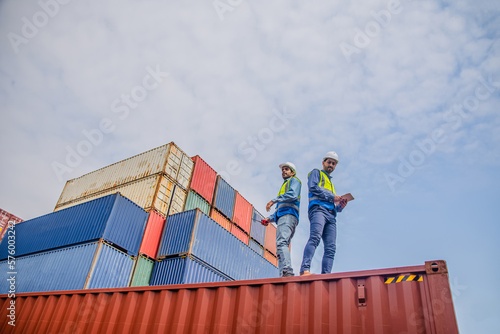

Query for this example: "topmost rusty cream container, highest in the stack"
[56,143,184,207]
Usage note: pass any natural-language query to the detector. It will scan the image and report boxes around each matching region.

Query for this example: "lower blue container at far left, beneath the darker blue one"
[0,242,134,294]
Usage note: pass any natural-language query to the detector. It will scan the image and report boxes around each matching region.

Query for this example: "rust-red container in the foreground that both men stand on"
[0,261,458,334]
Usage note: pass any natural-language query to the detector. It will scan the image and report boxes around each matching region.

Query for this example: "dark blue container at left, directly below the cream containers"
[0,193,148,260]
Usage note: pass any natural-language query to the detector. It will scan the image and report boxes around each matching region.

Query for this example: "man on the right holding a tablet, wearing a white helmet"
[300,152,347,276]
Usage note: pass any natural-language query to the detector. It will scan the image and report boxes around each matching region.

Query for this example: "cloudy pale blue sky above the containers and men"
[0,0,500,333]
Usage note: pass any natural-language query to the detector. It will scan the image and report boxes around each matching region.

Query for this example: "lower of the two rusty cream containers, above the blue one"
[54,174,175,216]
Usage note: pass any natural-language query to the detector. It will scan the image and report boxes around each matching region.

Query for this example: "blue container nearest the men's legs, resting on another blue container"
[158,209,278,280]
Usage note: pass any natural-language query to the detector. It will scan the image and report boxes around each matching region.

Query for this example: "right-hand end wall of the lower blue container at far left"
[85,242,134,289]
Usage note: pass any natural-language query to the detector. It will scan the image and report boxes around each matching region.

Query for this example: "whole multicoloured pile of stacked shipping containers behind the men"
[0,142,278,291]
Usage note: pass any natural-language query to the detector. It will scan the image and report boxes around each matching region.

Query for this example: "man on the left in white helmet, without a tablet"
[262,162,302,277]
